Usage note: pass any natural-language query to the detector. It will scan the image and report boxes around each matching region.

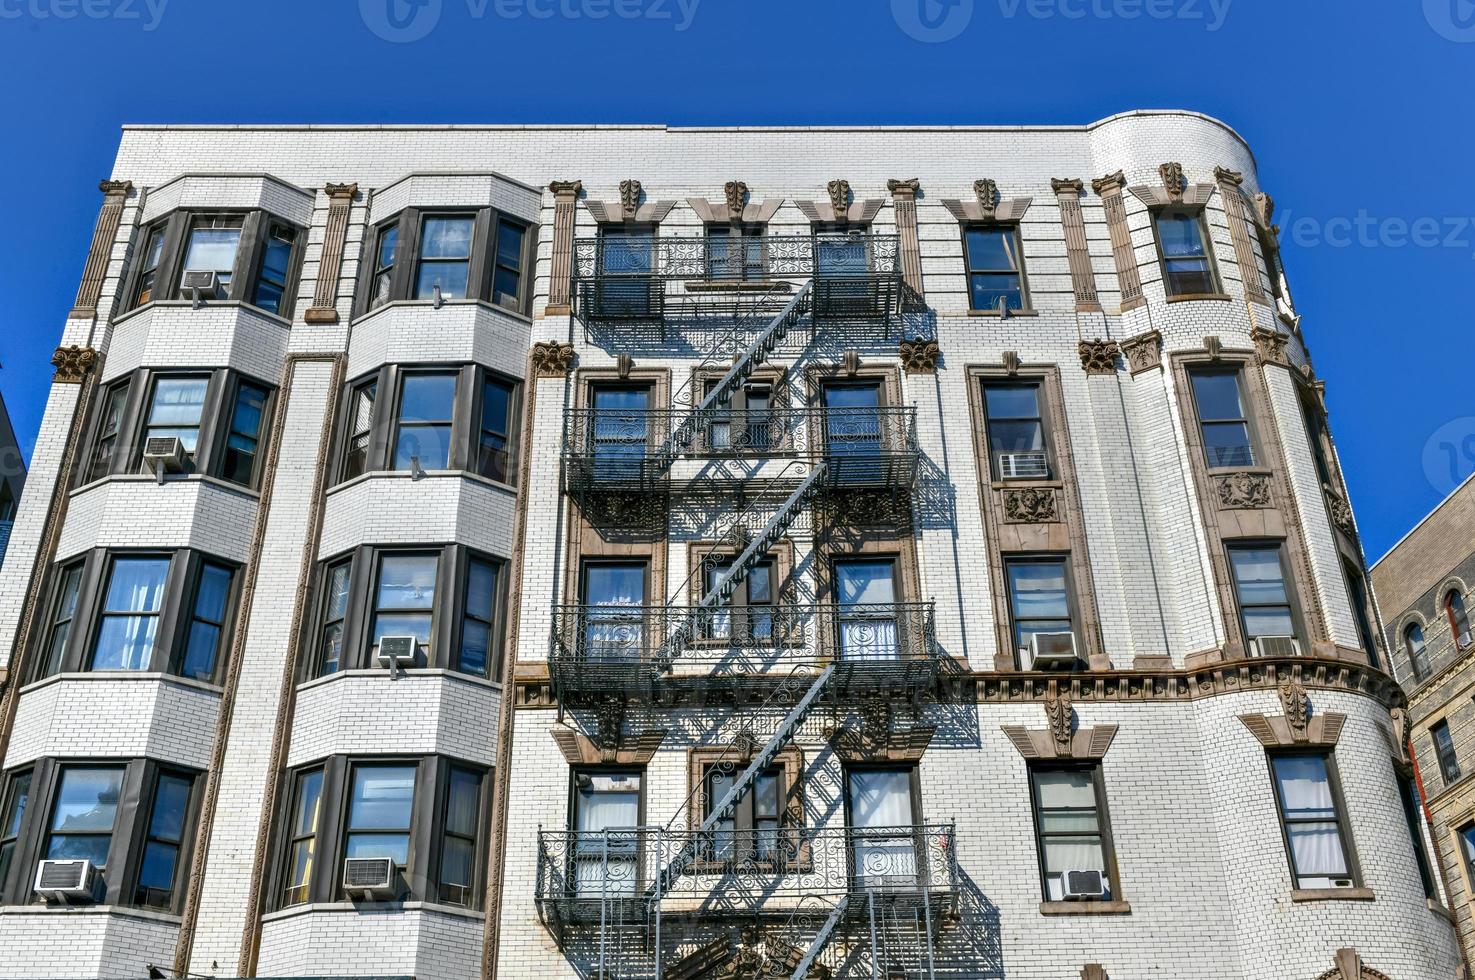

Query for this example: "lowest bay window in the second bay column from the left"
[271,756,488,908]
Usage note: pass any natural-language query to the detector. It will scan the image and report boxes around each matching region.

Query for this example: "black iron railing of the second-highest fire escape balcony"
[563,406,919,487]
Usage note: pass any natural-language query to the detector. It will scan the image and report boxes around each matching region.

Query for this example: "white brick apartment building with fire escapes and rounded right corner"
[0,112,1462,980]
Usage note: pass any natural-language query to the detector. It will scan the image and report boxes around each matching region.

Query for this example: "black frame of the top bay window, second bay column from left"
[354,207,538,317]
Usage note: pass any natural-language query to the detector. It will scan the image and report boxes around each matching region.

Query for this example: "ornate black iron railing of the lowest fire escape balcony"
[534,824,959,924]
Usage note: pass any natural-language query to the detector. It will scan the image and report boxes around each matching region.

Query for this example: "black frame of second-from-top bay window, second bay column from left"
[333,363,522,490]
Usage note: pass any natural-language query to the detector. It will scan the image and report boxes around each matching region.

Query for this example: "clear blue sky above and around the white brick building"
[0,0,1475,558]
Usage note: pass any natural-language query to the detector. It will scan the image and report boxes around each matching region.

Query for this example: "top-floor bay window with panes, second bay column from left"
[360,208,534,313]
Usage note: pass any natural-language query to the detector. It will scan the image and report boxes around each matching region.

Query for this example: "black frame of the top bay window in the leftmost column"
[119,208,307,320]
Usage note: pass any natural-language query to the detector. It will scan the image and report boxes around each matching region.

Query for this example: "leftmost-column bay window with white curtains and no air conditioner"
[34,549,236,683]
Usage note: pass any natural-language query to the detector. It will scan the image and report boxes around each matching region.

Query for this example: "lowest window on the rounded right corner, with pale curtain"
[1270,754,1354,888]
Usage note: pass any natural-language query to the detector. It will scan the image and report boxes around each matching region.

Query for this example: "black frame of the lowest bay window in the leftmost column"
[0,756,205,915]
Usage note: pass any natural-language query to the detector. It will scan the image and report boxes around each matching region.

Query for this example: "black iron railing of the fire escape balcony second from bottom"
[552,602,938,694]
